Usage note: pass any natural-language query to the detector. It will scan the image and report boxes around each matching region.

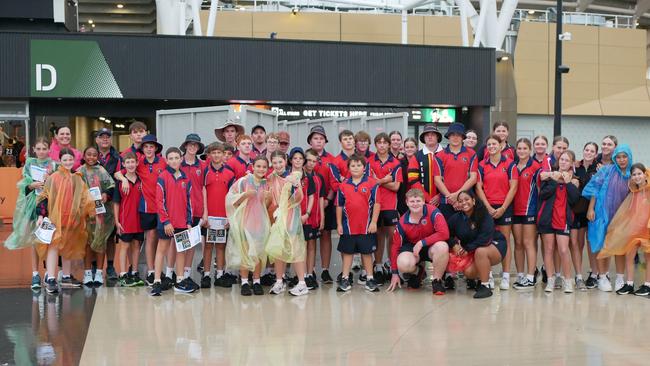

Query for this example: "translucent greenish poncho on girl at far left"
[4,158,55,250]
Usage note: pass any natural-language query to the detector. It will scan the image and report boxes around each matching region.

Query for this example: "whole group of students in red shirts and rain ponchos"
[5,118,650,298]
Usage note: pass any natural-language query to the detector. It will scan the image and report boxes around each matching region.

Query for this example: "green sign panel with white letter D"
[30,40,123,98]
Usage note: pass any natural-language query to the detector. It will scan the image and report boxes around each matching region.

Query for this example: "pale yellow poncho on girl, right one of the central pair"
[266,172,306,263]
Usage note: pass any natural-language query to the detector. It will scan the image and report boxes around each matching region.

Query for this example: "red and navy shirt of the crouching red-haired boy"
[390,205,449,273]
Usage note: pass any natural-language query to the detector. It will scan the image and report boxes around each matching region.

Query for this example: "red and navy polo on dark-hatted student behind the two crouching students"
[436,145,478,203]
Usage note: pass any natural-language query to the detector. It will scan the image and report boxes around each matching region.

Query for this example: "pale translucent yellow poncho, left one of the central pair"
[226,174,271,271]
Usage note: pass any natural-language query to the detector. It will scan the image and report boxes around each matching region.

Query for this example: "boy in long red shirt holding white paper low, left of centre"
[151,147,196,296]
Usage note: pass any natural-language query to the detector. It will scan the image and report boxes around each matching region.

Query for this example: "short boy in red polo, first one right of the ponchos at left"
[113,151,144,287]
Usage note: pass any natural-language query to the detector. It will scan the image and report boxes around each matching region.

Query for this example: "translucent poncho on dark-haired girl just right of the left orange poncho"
[79,164,115,252]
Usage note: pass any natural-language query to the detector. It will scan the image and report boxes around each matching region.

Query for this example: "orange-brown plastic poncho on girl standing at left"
[36,167,95,260]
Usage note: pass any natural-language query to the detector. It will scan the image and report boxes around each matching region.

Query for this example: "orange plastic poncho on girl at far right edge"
[598,170,650,259]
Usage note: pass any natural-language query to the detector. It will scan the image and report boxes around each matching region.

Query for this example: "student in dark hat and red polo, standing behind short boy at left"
[115,135,167,286]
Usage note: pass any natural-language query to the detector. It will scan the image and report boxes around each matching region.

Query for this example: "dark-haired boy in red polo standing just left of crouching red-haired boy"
[369,132,402,285]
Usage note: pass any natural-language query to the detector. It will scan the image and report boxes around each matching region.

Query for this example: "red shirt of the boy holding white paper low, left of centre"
[156,167,192,229]
